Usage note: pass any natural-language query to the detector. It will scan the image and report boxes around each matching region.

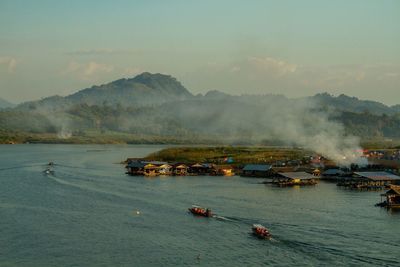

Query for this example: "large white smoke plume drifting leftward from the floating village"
[170,96,366,165]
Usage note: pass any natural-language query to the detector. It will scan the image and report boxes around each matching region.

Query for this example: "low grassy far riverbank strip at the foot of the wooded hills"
[0,129,400,149]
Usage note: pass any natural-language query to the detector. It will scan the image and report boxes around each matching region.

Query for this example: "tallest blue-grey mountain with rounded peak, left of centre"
[18,72,193,110]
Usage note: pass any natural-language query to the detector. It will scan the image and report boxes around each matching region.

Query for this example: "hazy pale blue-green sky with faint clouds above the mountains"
[0,0,400,105]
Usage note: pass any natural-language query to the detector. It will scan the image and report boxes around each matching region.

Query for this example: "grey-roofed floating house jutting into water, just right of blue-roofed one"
[272,172,318,186]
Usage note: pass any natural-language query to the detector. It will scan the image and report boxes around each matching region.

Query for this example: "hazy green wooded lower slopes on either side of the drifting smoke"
[0,104,400,148]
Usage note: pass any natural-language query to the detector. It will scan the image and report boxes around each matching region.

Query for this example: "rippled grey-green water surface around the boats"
[0,145,400,266]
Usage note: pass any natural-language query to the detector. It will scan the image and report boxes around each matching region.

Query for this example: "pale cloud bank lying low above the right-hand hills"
[182,56,400,104]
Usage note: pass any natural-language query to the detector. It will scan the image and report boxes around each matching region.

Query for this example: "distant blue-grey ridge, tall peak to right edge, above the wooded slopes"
[14,72,400,115]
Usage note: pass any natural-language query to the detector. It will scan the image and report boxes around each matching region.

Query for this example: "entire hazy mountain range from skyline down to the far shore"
[0,73,400,143]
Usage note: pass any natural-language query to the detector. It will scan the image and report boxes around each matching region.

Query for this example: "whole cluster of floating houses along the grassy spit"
[124,150,400,208]
